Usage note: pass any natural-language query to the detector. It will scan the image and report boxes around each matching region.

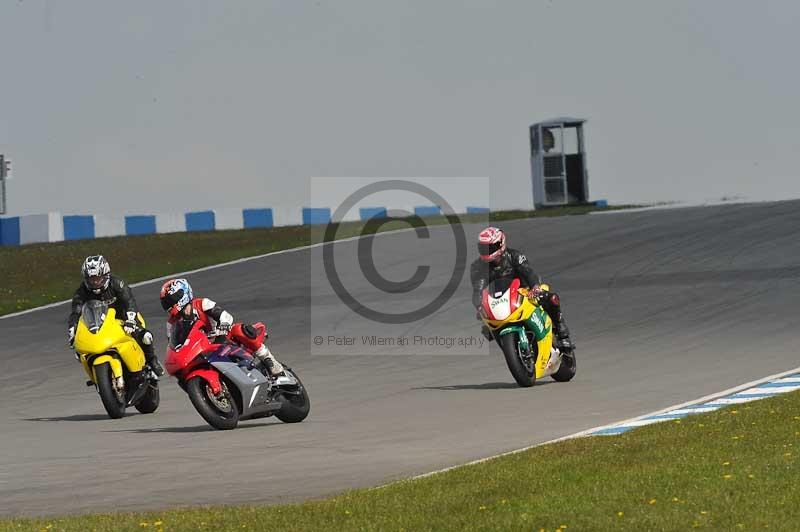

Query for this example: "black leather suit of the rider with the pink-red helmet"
[469,248,573,349]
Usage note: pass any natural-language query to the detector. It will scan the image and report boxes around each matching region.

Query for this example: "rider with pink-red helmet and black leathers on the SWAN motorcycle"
[470,227,575,352]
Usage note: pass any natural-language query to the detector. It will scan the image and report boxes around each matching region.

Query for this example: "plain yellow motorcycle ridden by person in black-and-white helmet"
[74,301,160,419]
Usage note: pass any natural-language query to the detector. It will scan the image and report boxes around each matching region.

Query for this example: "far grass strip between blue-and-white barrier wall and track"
[0,205,625,316]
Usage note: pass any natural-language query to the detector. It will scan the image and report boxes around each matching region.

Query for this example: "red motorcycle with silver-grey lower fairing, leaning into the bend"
[164,320,311,430]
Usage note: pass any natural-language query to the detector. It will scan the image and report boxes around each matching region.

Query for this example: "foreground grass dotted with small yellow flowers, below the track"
[0,392,800,532]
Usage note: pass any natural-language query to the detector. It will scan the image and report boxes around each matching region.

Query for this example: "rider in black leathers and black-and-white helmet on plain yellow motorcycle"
[67,255,164,376]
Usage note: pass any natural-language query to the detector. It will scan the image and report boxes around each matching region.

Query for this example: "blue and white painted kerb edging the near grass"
[583,373,800,436]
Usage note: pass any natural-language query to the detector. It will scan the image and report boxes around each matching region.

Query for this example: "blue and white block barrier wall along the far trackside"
[0,205,489,246]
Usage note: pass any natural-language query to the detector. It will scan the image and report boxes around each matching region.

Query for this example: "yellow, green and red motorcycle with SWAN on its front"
[480,278,577,387]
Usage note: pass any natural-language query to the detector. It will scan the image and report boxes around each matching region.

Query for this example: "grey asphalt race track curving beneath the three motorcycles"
[0,202,800,516]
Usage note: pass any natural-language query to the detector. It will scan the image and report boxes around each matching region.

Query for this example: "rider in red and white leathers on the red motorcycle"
[161,279,283,377]
